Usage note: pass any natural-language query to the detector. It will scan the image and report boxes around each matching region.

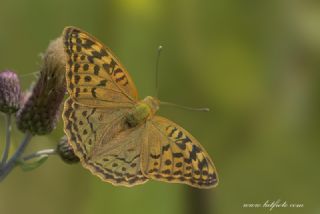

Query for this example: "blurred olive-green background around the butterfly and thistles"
[0,0,320,214]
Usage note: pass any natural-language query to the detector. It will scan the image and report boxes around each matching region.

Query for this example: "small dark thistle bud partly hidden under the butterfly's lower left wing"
[57,136,80,164]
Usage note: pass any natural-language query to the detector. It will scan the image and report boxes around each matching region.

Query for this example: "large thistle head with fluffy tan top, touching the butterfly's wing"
[17,37,66,135]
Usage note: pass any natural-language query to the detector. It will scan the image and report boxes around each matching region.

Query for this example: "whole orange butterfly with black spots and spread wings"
[63,27,218,188]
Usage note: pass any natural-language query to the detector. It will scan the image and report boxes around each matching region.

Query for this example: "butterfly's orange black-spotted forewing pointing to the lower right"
[142,116,218,188]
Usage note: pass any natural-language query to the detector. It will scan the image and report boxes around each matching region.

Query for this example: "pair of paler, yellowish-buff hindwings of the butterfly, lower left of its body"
[63,98,147,186]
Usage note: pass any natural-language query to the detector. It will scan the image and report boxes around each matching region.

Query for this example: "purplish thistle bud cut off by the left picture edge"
[0,71,21,114]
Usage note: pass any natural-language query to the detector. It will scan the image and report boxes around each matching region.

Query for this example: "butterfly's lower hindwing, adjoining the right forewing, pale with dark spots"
[87,120,148,186]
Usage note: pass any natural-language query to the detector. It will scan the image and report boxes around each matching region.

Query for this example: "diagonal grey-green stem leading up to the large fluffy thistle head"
[0,131,32,182]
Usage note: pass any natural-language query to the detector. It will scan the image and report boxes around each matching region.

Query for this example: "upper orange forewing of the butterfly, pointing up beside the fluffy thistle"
[63,27,138,107]
